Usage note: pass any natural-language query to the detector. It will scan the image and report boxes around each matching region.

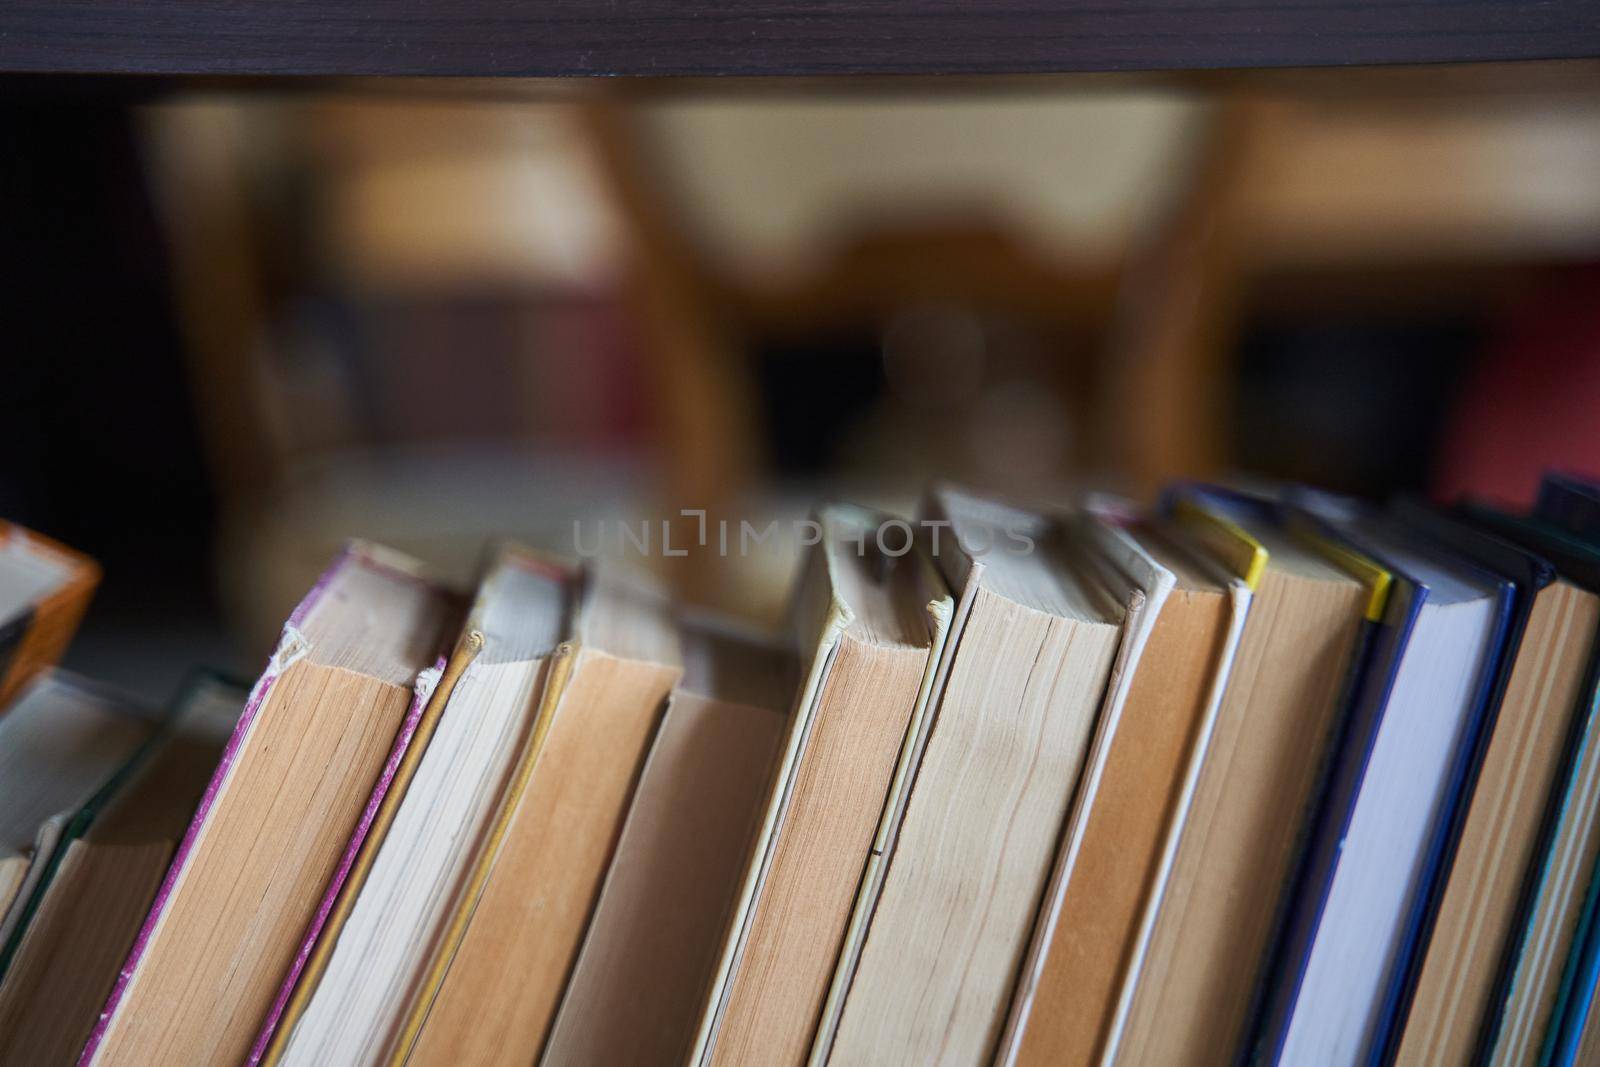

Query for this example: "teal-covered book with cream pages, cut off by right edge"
[1461,506,1600,1064]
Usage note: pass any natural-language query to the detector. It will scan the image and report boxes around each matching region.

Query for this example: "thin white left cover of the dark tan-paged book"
[997,515,1176,1064]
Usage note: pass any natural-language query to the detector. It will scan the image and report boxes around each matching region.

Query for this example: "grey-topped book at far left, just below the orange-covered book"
[0,670,158,953]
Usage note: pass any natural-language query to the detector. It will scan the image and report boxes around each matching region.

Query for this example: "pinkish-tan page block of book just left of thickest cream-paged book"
[712,506,942,1067]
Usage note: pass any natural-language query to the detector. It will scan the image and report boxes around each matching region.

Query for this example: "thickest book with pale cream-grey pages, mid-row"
[821,490,1126,1064]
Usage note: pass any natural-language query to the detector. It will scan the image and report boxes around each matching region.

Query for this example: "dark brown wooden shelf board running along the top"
[9,0,1600,77]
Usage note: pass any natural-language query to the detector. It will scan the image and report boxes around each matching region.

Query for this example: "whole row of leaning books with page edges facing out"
[0,477,1600,1067]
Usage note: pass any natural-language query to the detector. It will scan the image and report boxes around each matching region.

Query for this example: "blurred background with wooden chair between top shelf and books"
[9,64,1600,697]
